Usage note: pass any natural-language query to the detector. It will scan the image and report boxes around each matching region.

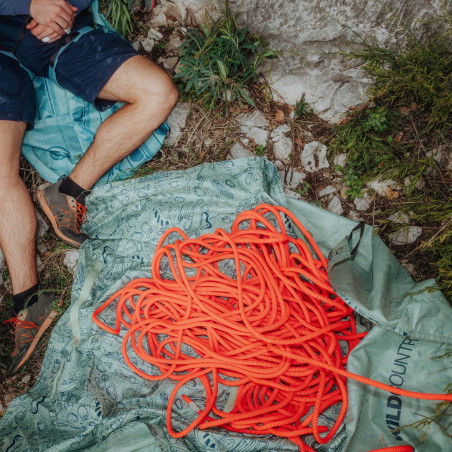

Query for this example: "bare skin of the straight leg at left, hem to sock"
[0,120,37,294]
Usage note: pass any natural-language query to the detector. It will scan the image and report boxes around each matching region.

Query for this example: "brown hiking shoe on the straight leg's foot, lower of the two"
[3,293,57,373]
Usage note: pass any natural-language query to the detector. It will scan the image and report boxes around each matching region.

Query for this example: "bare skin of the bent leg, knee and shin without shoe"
[70,55,178,189]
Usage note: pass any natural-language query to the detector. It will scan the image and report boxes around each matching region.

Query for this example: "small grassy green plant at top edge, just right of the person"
[100,0,154,37]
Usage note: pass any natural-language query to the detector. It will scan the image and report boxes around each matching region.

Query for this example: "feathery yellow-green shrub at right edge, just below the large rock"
[351,32,452,132]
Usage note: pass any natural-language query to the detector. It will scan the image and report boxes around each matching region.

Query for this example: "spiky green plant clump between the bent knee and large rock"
[175,2,277,111]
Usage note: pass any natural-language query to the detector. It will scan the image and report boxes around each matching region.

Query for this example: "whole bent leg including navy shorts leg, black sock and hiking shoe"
[37,30,178,246]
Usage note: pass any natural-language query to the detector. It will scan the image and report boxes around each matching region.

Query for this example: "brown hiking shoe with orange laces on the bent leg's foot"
[36,180,87,248]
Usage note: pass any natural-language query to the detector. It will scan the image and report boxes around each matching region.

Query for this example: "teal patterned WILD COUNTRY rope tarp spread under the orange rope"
[0,158,452,452]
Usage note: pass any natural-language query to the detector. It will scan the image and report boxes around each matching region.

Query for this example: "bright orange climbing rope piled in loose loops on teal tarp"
[93,205,452,451]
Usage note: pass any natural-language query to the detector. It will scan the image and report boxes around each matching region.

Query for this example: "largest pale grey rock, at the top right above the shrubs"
[224,0,444,122]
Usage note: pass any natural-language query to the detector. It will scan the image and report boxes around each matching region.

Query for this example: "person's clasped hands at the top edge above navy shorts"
[30,0,77,33]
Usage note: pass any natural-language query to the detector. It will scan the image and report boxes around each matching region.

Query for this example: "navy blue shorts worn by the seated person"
[0,28,138,125]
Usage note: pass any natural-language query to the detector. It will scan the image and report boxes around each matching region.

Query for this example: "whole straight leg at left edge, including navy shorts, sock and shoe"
[0,52,55,372]
